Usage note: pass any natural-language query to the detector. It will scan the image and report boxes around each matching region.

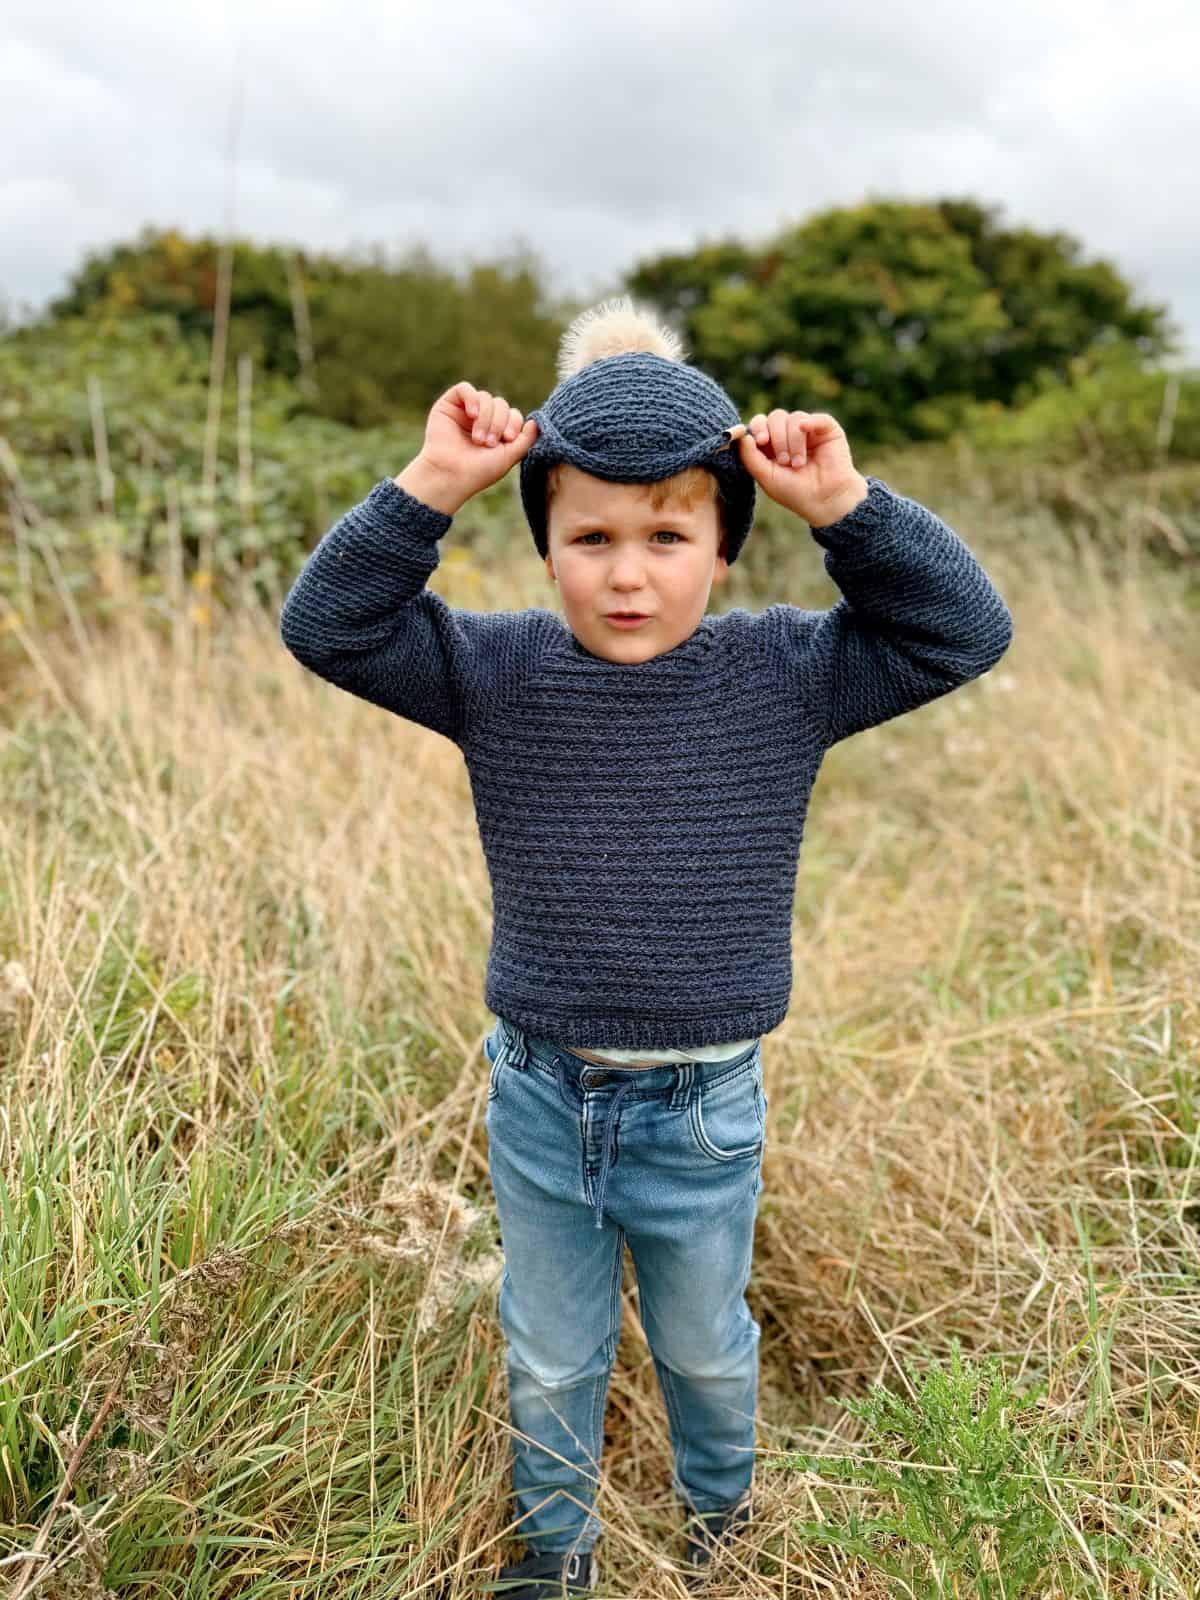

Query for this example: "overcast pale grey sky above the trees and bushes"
[0,0,1200,362]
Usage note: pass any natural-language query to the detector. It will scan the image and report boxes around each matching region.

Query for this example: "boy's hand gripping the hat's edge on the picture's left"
[395,381,538,509]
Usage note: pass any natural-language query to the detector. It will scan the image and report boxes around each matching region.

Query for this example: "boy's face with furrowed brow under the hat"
[546,464,730,662]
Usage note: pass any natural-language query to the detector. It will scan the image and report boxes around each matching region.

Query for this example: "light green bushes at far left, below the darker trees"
[0,314,489,617]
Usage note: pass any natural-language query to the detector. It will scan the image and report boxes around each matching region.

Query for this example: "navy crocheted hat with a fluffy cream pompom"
[520,296,755,563]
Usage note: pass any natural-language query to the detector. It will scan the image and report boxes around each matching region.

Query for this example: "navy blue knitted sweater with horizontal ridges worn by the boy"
[280,477,1013,1050]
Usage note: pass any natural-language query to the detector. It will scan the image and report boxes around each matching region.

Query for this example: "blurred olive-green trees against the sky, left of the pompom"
[48,229,566,427]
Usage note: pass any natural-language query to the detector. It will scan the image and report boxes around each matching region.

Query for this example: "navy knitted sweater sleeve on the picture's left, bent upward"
[280,478,528,746]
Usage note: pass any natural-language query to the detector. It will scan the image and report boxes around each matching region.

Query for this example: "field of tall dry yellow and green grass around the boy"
[0,462,1200,1600]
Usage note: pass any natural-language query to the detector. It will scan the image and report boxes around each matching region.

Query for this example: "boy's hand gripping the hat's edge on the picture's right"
[733,410,870,528]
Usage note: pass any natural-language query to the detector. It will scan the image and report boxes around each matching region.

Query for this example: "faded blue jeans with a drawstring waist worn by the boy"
[483,1018,766,1552]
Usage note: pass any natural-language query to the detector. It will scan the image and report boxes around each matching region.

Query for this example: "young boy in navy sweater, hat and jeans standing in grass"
[280,299,1013,1600]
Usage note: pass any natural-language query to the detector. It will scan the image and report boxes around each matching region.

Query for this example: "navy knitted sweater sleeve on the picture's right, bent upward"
[758,477,1013,749]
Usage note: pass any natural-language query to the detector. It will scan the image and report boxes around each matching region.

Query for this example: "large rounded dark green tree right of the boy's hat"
[626,200,1171,443]
